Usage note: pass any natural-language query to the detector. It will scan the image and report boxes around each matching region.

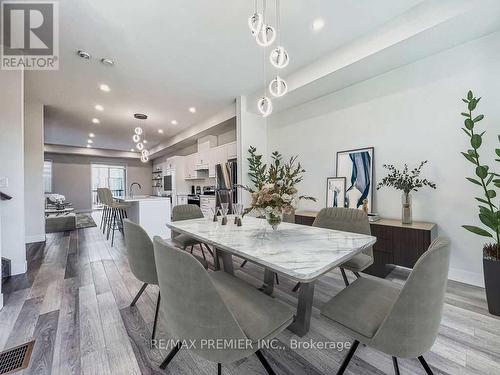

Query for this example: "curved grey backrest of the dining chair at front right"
[373,238,450,358]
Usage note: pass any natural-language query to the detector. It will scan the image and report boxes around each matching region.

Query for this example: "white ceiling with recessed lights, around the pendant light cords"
[26,0,422,150]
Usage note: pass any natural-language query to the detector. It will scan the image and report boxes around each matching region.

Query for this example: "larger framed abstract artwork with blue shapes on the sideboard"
[336,147,374,212]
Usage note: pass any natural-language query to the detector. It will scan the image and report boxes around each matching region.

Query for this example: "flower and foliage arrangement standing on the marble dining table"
[242,147,316,230]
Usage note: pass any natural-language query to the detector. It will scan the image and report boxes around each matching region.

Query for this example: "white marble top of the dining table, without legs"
[167,216,377,282]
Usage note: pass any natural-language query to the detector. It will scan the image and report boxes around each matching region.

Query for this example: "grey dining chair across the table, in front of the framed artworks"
[293,207,373,292]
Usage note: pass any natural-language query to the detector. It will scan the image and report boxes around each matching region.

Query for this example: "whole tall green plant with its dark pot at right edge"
[462,91,500,316]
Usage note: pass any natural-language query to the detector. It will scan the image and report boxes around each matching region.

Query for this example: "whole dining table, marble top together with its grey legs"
[167,216,376,336]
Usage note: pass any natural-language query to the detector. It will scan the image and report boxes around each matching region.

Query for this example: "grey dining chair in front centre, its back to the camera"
[153,237,293,374]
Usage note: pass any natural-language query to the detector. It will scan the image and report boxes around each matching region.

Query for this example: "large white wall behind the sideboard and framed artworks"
[268,32,500,285]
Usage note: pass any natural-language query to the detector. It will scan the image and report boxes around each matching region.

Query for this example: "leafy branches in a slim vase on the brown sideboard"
[377,160,436,224]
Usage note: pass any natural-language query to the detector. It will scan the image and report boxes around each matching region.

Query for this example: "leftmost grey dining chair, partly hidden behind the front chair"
[123,219,160,339]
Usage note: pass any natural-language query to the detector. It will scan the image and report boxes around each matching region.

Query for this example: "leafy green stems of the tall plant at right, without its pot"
[462,91,500,261]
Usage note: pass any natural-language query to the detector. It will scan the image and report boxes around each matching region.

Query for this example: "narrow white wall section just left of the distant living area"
[24,101,45,243]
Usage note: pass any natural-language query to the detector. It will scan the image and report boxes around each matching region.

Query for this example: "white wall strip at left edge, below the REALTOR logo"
[0,70,26,280]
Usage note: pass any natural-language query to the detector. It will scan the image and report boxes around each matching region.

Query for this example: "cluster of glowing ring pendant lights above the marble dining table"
[248,0,290,117]
